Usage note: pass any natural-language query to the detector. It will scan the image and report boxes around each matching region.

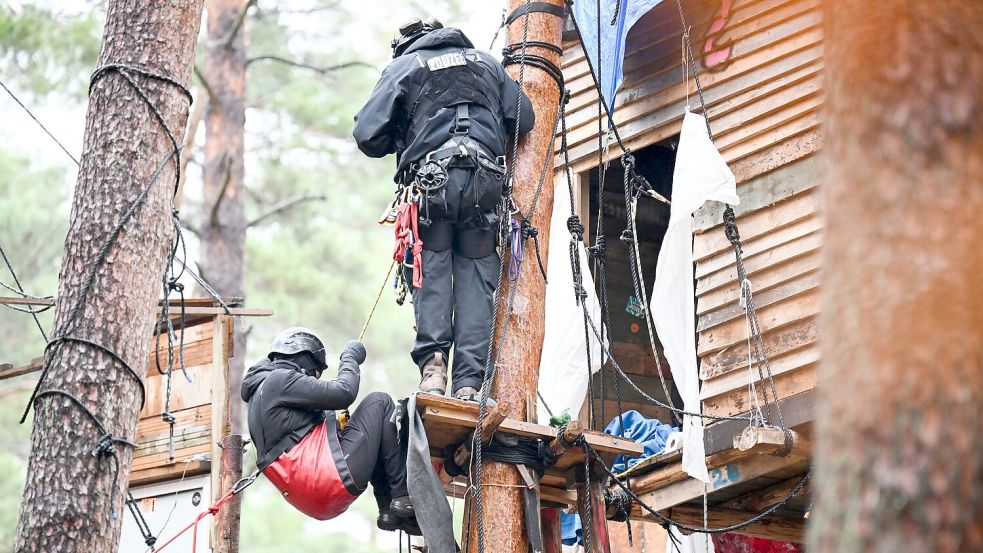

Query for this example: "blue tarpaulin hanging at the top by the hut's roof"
[573,0,662,113]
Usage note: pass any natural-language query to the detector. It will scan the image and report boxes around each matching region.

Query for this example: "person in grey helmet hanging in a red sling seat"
[241,327,416,531]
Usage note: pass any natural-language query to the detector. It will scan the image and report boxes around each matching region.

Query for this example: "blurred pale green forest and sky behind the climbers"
[0,0,504,553]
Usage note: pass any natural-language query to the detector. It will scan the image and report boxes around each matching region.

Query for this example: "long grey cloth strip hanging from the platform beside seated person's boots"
[405,394,458,553]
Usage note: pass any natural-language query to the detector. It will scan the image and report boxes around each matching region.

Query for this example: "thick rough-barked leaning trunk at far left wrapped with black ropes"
[15,0,202,552]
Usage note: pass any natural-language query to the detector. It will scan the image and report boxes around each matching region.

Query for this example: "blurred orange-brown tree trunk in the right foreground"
[809,0,983,553]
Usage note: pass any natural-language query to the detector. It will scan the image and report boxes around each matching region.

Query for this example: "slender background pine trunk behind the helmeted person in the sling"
[200,0,249,553]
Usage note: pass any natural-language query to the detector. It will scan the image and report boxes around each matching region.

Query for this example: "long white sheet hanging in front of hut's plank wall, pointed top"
[650,111,740,482]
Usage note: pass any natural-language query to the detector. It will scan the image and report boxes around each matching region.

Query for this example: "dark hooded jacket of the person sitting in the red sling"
[240,353,360,468]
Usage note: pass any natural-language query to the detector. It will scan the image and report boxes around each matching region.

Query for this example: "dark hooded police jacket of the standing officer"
[353,27,536,180]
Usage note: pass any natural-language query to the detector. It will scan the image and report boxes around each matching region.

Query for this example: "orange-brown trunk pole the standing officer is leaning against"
[469,0,563,553]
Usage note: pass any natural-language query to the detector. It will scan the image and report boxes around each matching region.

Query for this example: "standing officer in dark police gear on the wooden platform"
[353,20,535,399]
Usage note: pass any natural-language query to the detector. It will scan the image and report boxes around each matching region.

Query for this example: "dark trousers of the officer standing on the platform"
[407,167,501,391]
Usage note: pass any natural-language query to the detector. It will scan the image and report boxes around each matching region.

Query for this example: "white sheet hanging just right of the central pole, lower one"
[536,178,601,424]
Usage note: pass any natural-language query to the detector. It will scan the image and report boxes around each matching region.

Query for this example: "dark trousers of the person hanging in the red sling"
[340,392,408,511]
